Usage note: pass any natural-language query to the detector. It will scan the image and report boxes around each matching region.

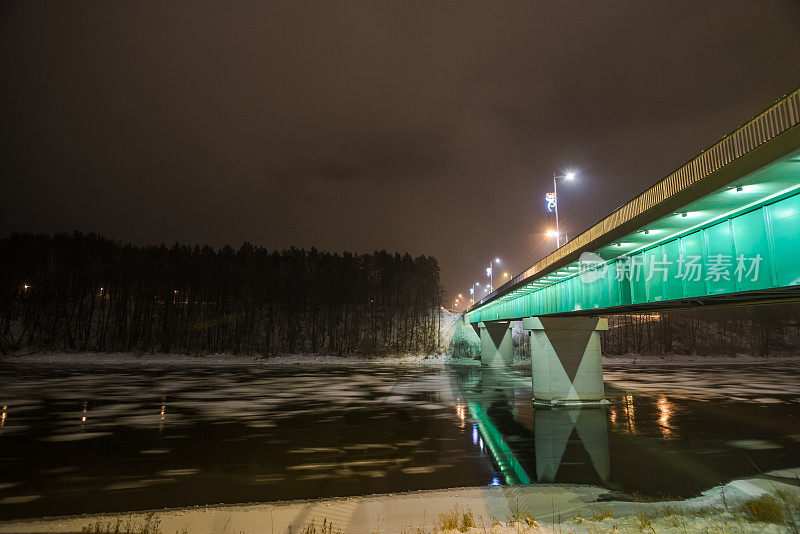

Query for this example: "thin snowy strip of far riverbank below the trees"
[0,351,800,368]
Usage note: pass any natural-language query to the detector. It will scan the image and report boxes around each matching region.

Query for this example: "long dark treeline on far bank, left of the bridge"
[0,233,442,355]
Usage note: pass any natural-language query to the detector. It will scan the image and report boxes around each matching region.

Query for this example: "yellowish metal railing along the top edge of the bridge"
[470,89,800,310]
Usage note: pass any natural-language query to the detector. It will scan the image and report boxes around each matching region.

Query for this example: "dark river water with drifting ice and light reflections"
[0,364,800,519]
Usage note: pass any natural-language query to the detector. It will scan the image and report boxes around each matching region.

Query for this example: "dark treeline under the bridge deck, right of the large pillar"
[602,303,800,356]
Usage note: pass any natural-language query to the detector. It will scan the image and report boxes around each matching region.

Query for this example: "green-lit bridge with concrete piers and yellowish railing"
[460,89,800,404]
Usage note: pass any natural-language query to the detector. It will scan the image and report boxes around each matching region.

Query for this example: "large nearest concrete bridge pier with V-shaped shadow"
[522,317,608,404]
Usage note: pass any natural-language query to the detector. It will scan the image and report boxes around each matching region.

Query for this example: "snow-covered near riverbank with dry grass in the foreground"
[0,474,800,534]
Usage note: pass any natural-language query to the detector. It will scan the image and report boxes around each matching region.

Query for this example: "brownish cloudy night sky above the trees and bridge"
[0,0,800,302]
